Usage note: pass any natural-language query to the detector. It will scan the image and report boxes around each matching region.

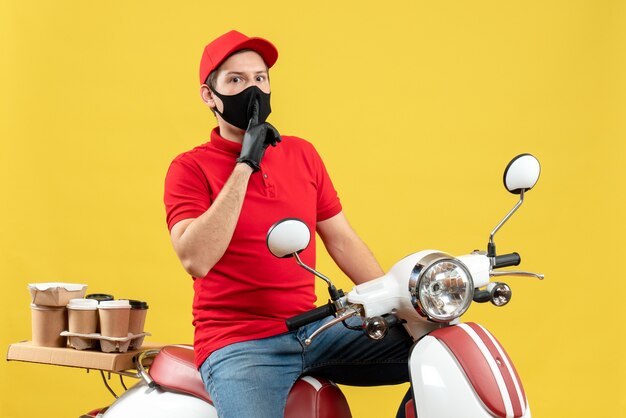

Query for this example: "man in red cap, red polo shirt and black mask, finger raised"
[164,31,411,418]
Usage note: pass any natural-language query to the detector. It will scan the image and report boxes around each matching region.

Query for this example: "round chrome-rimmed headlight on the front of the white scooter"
[409,253,474,322]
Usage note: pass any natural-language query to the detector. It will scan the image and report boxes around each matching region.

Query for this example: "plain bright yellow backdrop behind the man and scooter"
[0,0,626,418]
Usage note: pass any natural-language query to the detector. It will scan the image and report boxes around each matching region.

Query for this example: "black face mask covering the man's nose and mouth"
[210,86,272,131]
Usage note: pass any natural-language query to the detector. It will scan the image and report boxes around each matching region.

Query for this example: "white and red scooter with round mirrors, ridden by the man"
[81,154,543,418]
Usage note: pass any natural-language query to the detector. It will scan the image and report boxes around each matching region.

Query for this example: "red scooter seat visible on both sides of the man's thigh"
[149,345,352,418]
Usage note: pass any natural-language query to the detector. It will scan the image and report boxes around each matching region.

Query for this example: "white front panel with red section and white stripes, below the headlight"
[409,323,530,418]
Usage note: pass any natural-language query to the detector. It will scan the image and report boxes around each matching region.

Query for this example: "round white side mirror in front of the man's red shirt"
[266,218,311,258]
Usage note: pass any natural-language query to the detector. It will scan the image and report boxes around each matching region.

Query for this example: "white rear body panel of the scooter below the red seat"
[102,381,218,418]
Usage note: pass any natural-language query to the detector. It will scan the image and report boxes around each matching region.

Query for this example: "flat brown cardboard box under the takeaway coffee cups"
[7,341,164,372]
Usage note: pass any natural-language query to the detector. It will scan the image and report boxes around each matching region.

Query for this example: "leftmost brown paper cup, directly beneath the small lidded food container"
[30,304,67,347]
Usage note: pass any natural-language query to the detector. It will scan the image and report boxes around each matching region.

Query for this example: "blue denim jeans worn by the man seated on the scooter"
[200,317,413,418]
